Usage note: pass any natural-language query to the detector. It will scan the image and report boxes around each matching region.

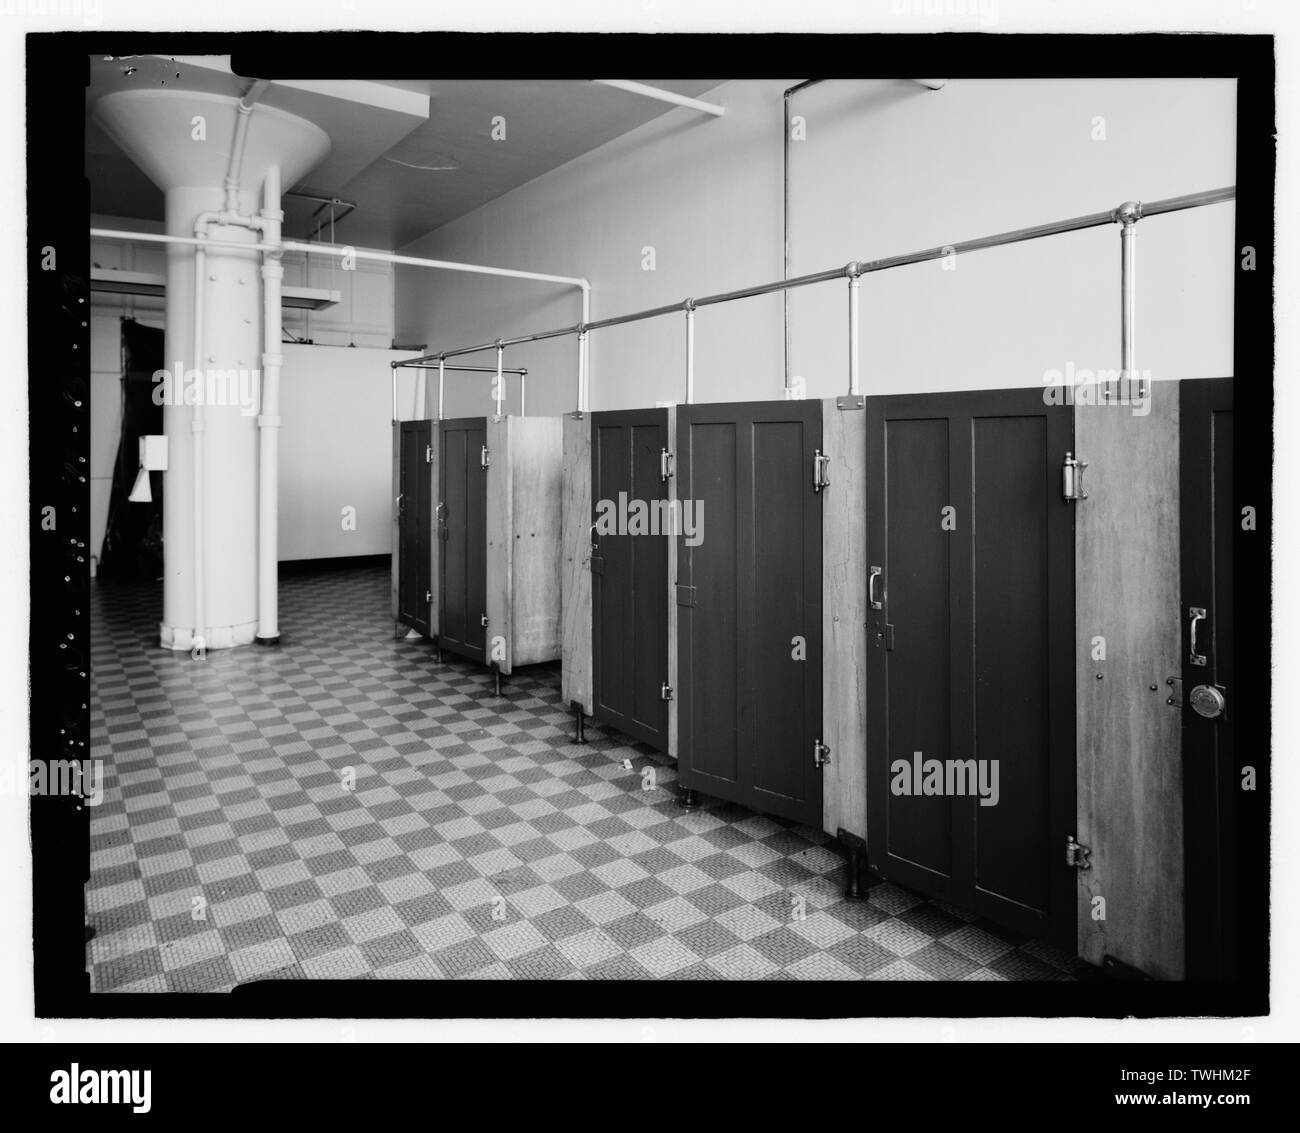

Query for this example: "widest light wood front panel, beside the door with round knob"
[1076,382,1186,980]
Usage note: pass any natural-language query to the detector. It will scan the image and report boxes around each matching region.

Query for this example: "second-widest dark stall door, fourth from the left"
[677,401,822,826]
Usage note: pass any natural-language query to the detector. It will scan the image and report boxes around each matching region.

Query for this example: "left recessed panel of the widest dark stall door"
[867,405,953,893]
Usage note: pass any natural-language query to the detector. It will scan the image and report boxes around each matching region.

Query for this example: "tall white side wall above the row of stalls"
[397,79,1236,416]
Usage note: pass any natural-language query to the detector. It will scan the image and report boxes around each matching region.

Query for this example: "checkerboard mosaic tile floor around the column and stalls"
[86,567,1092,991]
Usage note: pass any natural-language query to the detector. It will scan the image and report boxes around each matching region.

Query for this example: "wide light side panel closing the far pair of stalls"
[486,417,562,676]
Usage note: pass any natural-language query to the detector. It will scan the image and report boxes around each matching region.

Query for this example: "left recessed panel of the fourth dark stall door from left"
[677,423,746,798]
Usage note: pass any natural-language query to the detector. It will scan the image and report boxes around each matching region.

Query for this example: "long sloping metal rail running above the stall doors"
[412,186,1236,376]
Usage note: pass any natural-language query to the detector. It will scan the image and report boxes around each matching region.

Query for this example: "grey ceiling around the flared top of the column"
[86,56,723,248]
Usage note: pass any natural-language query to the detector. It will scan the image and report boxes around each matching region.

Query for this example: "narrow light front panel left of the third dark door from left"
[560,413,594,716]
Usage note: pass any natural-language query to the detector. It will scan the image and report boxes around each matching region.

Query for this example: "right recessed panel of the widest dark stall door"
[969,412,1074,930]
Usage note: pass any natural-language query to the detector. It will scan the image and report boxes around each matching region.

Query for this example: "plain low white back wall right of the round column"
[280,343,423,563]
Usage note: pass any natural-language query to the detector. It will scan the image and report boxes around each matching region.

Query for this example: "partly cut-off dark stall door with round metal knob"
[1179,378,1237,980]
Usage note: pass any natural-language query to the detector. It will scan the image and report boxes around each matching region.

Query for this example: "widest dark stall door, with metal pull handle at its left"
[867,390,1076,950]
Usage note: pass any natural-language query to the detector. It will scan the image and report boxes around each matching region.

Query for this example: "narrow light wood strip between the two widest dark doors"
[822,398,867,839]
